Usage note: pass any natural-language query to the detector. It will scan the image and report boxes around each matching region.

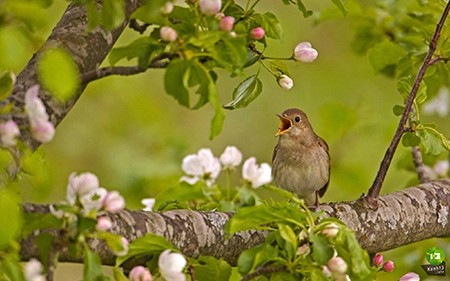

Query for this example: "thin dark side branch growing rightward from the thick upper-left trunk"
[81,53,178,85]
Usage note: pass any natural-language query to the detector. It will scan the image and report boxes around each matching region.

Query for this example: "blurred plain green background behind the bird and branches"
[0,1,450,281]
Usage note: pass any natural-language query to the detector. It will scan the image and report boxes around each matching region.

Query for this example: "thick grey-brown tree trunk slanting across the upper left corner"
[2,0,142,148]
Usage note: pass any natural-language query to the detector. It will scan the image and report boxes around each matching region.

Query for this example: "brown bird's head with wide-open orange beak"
[275,108,312,138]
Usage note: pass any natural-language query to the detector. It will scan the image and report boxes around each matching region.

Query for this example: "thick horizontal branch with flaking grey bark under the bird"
[21,180,450,267]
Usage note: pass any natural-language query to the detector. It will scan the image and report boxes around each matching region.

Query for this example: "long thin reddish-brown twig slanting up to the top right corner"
[367,2,450,199]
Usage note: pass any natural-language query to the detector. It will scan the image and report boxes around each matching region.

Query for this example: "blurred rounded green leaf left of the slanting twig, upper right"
[368,41,408,72]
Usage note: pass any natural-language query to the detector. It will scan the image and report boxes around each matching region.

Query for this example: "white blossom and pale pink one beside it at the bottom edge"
[129,250,187,281]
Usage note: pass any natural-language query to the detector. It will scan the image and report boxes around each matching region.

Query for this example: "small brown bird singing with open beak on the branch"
[272,108,330,207]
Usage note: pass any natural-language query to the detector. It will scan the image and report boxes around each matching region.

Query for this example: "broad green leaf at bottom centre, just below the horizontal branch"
[238,244,278,275]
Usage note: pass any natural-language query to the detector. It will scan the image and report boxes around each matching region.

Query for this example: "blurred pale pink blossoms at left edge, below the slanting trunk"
[0,85,55,147]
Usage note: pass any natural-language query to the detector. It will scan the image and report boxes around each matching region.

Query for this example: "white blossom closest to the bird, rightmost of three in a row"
[242,157,272,188]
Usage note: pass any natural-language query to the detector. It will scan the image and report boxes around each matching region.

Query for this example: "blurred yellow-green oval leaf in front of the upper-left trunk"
[38,48,80,101]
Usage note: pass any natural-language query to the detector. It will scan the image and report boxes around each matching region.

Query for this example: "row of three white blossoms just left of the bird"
[181,146,272,188]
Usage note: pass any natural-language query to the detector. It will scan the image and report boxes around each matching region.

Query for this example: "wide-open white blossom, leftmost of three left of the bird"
[180,148,221,186]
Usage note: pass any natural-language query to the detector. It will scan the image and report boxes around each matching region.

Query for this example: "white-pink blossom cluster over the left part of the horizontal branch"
[50,172,128,256]
